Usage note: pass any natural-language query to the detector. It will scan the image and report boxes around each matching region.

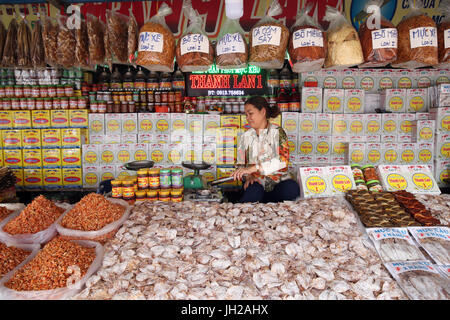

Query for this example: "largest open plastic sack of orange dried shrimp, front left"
[0,237,105,300]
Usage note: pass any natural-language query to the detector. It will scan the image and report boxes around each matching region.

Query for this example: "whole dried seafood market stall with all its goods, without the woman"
[0,0,450,300]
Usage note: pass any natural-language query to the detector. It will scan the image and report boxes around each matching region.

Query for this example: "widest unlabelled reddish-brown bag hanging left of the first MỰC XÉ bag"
[105,10,129,69]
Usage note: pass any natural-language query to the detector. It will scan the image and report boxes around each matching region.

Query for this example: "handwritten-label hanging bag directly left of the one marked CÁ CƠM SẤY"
[216,18,248,69]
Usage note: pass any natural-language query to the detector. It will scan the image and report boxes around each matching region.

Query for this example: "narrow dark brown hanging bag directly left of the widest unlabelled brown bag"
[86,14,105,65]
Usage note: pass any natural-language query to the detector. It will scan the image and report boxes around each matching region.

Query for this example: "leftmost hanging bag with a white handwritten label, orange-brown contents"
[136,3,175,72]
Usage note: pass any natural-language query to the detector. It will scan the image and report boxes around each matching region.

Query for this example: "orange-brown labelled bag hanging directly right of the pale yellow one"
[359,0,398,68]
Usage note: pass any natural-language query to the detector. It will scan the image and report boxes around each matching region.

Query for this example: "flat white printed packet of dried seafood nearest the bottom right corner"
[384,261,450,300]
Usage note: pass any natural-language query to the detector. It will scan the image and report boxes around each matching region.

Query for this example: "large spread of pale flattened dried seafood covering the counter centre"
[73,198,407,300]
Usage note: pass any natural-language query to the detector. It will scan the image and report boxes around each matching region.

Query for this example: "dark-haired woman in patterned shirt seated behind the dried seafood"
[232,96,300,203]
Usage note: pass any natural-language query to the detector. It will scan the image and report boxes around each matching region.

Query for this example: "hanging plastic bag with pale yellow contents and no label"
[323,6,364,68]
